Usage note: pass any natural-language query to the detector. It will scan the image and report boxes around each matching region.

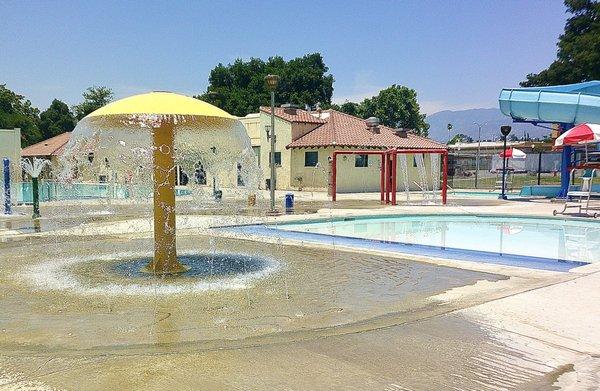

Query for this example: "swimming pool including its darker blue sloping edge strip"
[226,215,600,271]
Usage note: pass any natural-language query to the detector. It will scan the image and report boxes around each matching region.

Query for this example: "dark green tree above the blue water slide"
[521,0,600,87]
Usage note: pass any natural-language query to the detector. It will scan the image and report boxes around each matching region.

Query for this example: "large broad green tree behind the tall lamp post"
[196,53,333,116]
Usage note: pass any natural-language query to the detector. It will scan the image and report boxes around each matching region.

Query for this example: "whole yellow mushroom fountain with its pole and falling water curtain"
[63,92,256,274]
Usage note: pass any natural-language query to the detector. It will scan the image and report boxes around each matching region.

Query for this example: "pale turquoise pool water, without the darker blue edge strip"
[276,215,600,264]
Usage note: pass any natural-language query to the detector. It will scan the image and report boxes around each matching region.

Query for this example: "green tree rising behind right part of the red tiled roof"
[336,84,429,136]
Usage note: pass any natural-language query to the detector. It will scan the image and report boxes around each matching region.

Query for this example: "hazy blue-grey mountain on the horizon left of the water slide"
[425,109,550,143]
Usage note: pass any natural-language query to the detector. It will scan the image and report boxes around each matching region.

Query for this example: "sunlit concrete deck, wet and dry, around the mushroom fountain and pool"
[0,200,600,390]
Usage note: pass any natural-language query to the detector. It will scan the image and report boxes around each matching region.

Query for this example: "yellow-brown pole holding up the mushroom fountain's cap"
[146,120,186,274]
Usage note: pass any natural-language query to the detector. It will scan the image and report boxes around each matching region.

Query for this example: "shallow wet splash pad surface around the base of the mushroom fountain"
[0,227,501,352]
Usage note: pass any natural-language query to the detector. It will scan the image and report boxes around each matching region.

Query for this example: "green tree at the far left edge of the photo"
[0,84,42,147]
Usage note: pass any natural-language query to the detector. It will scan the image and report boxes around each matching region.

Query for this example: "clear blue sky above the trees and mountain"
[0,0,567,114]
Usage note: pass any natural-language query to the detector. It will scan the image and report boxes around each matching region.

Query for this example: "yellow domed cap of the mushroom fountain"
[87,91,235,119]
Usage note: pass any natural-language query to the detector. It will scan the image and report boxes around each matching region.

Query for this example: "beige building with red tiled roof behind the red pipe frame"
[240,107,446,192]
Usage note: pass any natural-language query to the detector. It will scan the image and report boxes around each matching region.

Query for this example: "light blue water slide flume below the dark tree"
[499,80,600,124]
